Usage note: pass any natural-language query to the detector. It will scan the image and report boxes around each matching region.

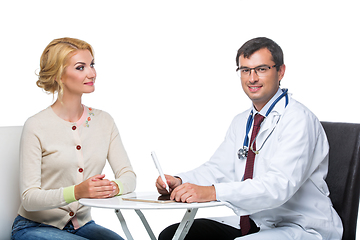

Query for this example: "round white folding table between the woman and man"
[79,193,224,240]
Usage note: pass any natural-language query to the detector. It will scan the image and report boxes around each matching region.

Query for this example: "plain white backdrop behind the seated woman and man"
[0,0,360,239]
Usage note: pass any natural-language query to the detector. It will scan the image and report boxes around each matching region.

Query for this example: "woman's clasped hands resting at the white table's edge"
[74,174,119,200]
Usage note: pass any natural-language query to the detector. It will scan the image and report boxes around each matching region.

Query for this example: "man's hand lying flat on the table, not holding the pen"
[170,183,216,203]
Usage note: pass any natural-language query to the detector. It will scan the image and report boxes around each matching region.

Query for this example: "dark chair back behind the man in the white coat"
[321,122,360,240]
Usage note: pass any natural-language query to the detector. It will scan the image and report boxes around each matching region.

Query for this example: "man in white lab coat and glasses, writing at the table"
[156,37,343,240]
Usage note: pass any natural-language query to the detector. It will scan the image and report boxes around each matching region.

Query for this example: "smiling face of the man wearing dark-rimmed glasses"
[239,48,285,111]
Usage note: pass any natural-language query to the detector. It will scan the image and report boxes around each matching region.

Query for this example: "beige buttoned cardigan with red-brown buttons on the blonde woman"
[18,107,136,229]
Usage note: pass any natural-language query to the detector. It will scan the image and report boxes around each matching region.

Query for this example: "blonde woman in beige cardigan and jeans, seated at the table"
[12,38,136,240]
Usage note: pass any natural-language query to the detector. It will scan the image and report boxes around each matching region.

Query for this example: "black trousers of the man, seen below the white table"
[159,218,259,240]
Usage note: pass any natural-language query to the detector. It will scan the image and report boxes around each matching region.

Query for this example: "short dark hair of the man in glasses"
[236,37,284,71]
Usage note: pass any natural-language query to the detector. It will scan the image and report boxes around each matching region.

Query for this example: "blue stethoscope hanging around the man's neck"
[238,88,289,159]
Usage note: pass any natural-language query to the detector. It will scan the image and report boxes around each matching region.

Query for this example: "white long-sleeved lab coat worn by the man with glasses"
[178,89,343,239]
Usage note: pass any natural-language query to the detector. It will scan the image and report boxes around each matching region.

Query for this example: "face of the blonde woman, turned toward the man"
[61,50,96,97]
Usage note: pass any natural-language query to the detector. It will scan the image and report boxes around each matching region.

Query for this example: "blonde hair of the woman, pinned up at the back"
[36,38,94,99]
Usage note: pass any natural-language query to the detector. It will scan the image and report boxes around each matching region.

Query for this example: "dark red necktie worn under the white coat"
[240,114,264,236]
